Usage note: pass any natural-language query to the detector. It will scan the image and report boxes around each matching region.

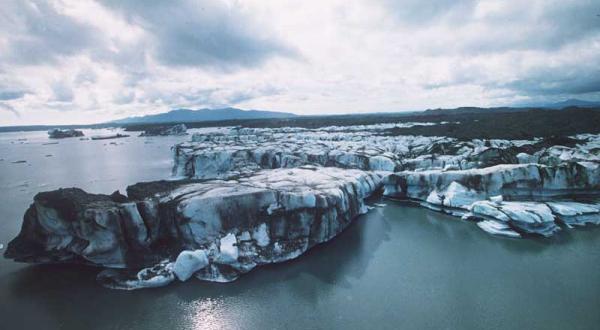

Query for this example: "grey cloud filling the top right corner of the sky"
[382,0,600,52]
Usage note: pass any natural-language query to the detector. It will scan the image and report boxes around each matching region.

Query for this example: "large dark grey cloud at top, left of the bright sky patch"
[102,0,292,69]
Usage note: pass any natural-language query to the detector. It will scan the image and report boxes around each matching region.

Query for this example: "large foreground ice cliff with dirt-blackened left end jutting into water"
[5,166,381,289]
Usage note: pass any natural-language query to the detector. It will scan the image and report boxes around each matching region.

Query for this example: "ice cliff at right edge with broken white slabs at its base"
[384,162,600,237]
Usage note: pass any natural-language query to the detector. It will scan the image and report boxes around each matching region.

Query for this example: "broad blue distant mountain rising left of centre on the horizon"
[110,108,297,125]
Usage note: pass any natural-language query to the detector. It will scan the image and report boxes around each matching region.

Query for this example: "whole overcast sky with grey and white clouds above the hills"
[0,0,600,125]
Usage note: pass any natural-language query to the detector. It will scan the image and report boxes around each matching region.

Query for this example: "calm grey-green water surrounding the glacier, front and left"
[0,132,600,329]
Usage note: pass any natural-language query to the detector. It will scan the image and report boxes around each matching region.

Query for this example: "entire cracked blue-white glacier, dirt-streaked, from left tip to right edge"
[4,123,600,290]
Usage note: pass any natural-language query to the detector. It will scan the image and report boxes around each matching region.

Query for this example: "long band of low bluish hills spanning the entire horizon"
[0,100,600,132]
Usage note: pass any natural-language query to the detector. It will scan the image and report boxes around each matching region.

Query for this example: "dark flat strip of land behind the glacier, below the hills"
[0,107,600,139]
